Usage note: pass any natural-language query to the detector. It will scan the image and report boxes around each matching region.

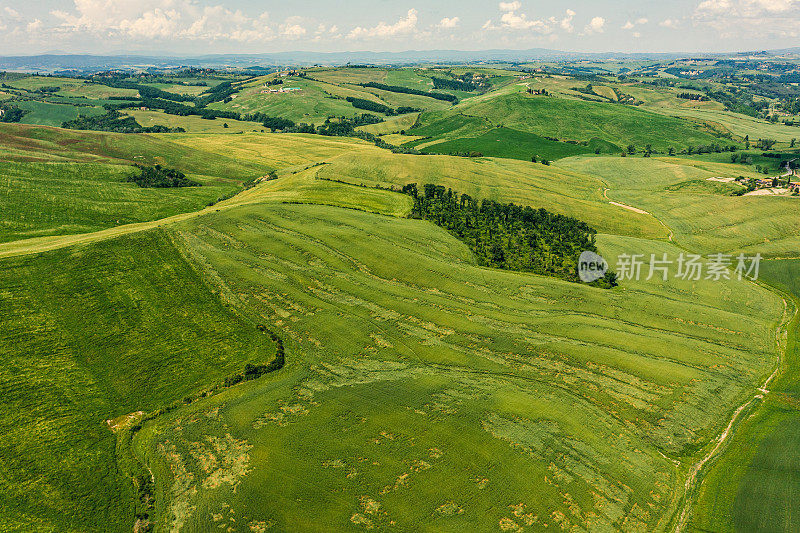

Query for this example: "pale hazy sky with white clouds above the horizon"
[0,0,800,55]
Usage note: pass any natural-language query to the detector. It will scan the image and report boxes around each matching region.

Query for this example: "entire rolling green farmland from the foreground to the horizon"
[0,56,800,533]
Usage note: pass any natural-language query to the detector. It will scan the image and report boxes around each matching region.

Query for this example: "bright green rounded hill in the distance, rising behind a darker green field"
[411,87,736,150]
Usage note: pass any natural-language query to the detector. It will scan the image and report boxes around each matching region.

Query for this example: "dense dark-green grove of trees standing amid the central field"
[402,183,615,287]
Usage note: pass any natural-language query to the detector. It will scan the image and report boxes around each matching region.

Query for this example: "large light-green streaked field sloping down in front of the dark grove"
[130,202,781,531]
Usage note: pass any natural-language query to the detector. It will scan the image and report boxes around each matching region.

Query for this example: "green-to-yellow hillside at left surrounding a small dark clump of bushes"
[0,125,388,242]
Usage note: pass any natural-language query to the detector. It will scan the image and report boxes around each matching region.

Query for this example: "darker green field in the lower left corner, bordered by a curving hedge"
[0,231,274,532]
